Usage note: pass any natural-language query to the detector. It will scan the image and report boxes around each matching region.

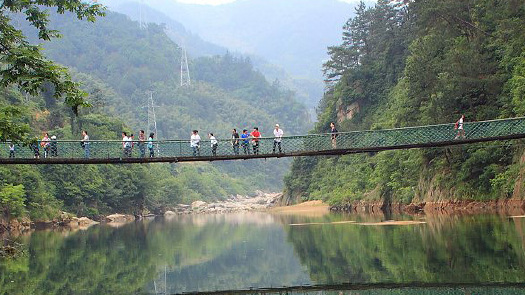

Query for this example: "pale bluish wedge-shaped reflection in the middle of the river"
[154,225,310,293]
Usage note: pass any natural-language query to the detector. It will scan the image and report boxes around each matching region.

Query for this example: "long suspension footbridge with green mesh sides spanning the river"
[0,117,525,164]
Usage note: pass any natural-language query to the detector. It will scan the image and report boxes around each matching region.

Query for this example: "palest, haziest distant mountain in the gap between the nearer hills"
[101,0,364,112]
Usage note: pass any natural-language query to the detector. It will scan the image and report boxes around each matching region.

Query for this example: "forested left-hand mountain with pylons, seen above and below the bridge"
[0,8,307,218]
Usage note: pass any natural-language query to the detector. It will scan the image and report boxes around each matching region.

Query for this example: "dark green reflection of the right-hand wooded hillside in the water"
[288,216,525,284]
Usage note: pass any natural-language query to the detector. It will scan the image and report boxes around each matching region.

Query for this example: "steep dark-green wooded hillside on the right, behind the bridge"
[285,0,525,205]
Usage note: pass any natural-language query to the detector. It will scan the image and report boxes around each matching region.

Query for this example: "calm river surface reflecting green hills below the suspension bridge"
[0,213,525,294]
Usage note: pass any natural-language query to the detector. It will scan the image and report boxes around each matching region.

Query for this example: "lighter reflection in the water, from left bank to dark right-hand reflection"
[0,214,309,295]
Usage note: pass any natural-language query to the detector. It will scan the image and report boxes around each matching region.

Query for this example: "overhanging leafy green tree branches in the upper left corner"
[0,0,104,140]
